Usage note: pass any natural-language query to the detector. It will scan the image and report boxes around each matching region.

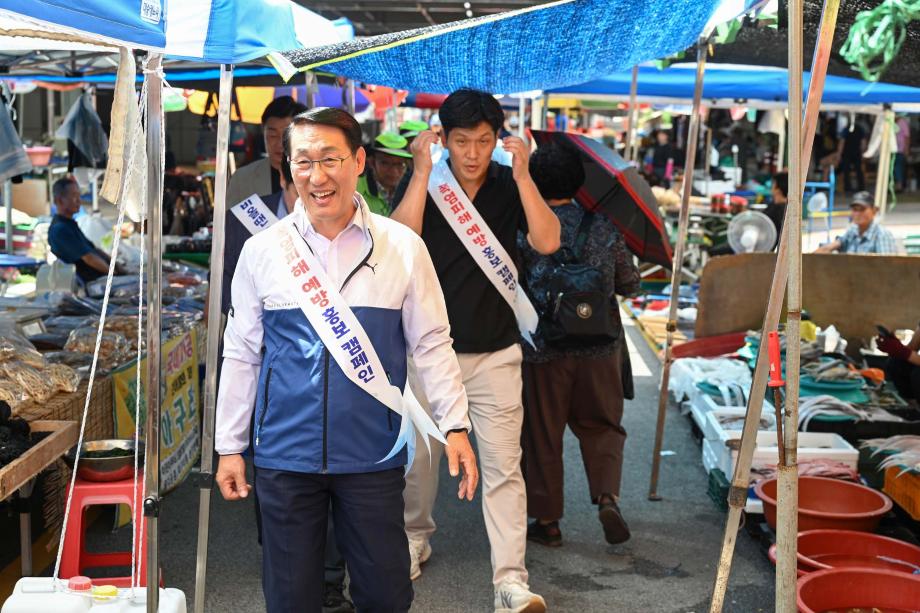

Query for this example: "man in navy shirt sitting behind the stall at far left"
[48,176,124,283]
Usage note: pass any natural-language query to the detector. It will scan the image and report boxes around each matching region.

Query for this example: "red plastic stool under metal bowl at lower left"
[60,477,164,587]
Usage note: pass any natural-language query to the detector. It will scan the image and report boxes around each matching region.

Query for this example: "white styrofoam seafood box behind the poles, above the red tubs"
[716,430,859,475]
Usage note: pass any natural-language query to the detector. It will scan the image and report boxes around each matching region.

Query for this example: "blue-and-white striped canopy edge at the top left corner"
[0,0,354,64]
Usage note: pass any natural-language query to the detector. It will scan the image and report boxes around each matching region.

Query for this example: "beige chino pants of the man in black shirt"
[403,345,527,585]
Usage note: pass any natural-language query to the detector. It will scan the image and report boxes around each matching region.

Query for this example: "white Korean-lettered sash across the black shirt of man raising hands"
[428,158,539,345]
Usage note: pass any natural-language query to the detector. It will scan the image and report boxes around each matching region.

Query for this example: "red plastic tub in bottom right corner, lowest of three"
[798,568,920,613]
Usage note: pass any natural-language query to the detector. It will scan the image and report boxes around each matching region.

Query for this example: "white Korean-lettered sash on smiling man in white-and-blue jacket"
[273,207,446,465]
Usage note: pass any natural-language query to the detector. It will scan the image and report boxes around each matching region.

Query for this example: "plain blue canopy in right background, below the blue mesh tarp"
[549,64,920,110]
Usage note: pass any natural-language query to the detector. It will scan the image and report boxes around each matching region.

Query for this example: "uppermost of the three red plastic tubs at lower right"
[754,477,891,532]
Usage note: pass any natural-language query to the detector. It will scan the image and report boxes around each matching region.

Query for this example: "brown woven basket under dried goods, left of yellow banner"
[15,377,115,441]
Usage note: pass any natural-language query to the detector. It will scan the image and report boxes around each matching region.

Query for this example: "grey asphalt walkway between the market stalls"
[102,325,774,613]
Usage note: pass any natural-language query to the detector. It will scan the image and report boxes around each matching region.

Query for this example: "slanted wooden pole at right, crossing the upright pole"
[709,0,840,613]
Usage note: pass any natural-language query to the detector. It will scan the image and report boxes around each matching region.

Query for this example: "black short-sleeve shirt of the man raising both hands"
[391,162,527,353]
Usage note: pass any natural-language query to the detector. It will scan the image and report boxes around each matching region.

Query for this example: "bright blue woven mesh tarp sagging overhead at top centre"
[272,0,761,93]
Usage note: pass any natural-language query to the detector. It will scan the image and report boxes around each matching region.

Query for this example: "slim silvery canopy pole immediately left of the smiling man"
[195,64,235,613]
